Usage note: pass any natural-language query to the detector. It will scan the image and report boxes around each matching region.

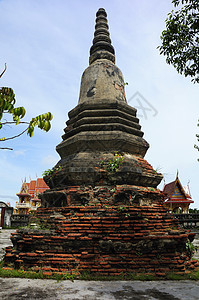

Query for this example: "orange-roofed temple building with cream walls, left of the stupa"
[14,178,49,215]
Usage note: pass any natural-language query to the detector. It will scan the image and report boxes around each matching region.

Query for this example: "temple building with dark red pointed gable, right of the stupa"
[163,174,194,214]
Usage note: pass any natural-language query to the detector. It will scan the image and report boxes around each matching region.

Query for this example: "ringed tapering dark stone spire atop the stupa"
[89,8,115,64]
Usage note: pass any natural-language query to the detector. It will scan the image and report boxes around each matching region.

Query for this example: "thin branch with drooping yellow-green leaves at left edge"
[0,64,53,150]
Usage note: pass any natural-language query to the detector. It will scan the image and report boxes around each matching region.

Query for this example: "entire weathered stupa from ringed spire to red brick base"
[5,8,198,276]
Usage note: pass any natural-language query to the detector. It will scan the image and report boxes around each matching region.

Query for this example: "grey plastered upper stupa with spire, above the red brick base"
[39,8,162,206]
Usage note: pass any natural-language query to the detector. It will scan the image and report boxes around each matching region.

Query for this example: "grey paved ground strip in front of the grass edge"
[0,278,199,300]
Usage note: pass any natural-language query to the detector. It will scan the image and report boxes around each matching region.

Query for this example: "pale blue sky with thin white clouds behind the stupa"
[0,0,199,208]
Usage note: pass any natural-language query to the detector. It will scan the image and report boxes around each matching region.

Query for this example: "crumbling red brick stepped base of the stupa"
[4,186,199,276]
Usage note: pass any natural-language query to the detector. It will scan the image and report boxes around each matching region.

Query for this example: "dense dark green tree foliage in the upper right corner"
[158,0,199,83]
